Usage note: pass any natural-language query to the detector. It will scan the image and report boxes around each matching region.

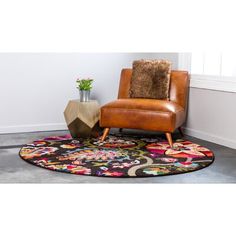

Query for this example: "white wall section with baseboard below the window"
[185,88,236,148]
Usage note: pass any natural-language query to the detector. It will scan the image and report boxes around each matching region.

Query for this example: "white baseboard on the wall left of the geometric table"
[0,123,67,134]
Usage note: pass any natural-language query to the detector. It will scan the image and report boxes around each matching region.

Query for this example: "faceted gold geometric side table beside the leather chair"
[64,100,100,138]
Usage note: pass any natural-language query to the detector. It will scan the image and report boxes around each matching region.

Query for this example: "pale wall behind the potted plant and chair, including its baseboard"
[0,53,178,133]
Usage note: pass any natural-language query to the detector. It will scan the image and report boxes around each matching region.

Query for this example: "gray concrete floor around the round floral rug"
[0,130,236,183]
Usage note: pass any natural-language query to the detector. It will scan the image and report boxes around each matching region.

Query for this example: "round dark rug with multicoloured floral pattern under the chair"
[19,134,214,177]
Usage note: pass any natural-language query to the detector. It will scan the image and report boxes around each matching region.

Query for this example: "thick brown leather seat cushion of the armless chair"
[100,98,185,132]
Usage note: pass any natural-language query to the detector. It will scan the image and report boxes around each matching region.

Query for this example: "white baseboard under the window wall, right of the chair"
[183,127,236,149]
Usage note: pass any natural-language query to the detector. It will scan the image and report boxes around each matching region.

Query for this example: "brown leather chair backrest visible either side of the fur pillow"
[118,69,189,109]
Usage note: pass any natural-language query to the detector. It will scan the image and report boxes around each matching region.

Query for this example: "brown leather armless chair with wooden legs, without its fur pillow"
[100,69,189,147]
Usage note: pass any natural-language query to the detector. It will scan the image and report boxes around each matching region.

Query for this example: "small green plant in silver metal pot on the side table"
[76,78,93,102]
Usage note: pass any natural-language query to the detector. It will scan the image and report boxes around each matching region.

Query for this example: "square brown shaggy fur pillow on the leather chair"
[130,60,171,99]
